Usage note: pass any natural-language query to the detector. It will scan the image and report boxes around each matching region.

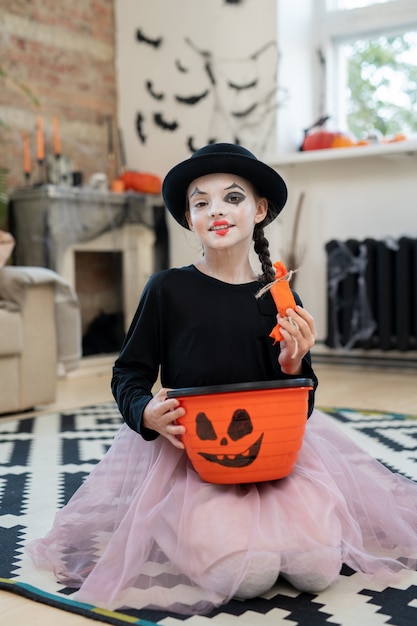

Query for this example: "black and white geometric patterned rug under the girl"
[0,403,417,626]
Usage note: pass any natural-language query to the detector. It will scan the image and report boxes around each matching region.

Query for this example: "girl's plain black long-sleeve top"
[111,265,317,440]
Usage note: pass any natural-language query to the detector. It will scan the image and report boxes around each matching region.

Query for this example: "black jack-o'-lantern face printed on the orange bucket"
[195,409,263,467]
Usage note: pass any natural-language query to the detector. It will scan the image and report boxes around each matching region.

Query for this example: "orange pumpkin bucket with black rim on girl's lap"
[168,378,313,484]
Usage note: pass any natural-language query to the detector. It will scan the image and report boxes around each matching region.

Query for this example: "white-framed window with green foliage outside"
[317,0,417,139]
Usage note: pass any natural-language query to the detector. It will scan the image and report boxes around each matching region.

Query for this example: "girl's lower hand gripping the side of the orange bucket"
[143,388,185,449]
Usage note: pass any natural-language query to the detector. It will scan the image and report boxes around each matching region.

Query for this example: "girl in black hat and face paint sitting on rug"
[29,144,417,614]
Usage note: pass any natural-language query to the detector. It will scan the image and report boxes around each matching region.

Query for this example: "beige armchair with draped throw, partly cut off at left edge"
[0,265,81,414]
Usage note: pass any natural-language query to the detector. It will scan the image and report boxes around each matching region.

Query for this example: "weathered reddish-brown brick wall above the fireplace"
[0,0,117,195]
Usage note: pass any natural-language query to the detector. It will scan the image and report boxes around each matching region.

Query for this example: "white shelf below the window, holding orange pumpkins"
[270,140,417,167]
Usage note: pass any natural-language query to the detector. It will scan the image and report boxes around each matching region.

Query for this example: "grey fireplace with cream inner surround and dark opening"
[9,185,168,355]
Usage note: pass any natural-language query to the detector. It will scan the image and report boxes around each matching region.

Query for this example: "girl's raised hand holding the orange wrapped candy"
[277,305,317,375]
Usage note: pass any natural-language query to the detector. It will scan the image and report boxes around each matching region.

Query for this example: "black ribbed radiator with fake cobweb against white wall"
[325,237,417,351]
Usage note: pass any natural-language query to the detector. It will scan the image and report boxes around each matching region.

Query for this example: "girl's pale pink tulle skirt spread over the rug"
[27,411,417,614]
